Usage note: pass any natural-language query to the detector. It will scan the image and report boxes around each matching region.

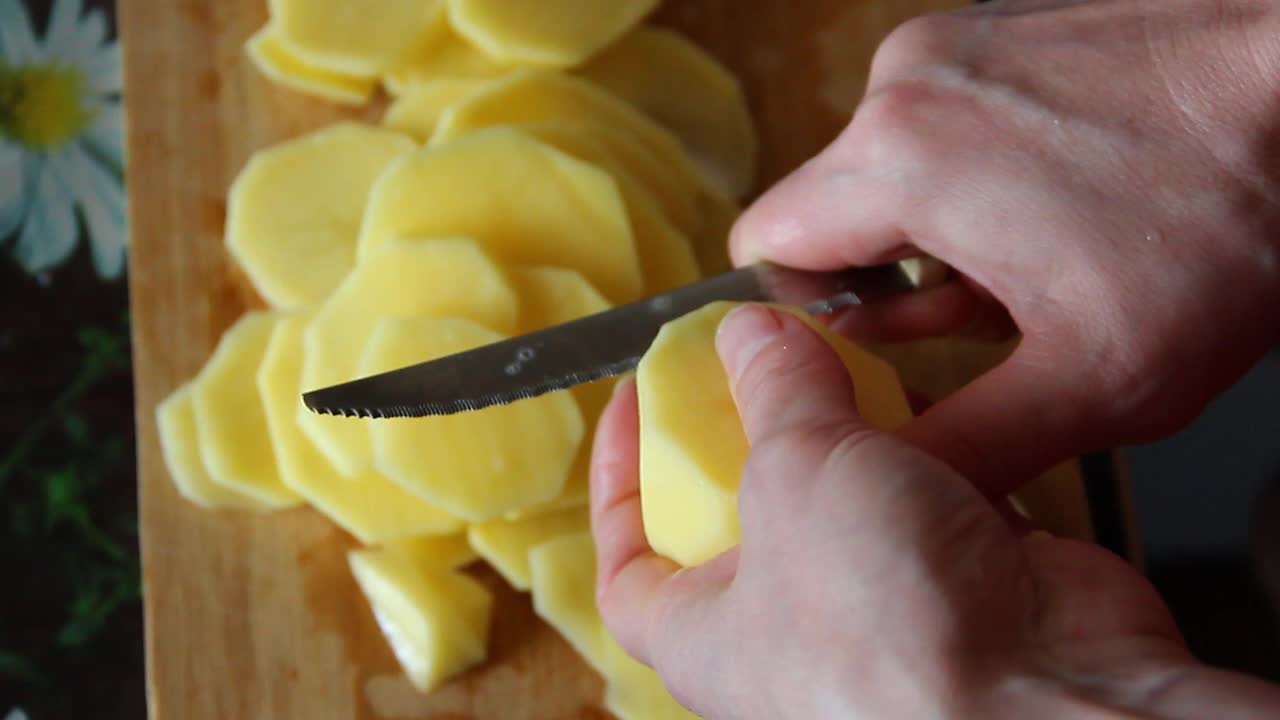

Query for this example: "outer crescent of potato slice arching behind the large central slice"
[431,69,701,232]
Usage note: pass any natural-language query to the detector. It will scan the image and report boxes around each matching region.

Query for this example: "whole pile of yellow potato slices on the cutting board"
[157,0,756,719]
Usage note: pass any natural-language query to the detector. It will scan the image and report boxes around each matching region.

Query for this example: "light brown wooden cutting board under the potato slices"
[120,0,1088,720]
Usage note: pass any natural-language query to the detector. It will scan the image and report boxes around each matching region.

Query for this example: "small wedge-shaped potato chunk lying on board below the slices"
[347,548,493,692]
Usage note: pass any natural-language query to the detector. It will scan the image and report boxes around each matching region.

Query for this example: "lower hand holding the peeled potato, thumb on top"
[591,306,1280,720]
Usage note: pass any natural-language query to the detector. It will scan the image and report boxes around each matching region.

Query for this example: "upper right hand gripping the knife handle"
[732,0,1280,497]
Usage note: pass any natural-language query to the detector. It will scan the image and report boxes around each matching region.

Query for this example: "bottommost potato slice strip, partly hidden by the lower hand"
[529,533,695,720]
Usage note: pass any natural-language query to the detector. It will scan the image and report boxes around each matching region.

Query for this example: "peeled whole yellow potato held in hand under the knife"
[636,302,911,566]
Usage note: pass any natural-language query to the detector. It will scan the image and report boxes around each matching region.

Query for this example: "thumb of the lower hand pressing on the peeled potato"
[716,305,863,447]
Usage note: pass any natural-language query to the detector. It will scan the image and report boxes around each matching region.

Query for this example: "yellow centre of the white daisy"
[0,64,93,150]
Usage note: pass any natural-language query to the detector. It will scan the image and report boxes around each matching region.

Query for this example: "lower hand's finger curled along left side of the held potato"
[590,379,727,665]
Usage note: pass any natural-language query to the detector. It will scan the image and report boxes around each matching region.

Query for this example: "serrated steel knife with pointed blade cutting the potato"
[302,259,946,418]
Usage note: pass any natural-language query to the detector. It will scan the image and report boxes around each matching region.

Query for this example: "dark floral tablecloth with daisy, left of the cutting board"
[0,0,145,720]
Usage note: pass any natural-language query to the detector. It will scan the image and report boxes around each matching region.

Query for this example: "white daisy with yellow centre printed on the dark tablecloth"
[0,0,127,278]
